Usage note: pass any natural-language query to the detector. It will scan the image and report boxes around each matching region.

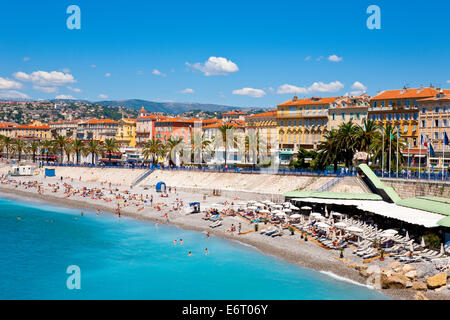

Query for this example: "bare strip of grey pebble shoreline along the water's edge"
[0,185,428,300]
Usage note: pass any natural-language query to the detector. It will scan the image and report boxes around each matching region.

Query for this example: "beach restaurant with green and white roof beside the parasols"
[284,191,450,243]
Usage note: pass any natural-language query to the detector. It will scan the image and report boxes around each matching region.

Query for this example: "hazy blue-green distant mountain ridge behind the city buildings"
[95,99,240,114]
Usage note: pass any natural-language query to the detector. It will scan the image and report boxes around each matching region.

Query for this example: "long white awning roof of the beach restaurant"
[292,198,445,228]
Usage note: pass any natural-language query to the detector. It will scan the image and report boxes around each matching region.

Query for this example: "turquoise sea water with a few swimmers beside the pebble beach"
[0,198,385,299]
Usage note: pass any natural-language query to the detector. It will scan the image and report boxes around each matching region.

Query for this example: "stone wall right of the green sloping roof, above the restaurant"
[381,178,450,199]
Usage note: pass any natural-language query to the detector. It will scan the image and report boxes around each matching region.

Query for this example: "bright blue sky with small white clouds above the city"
[0,0,450,108]
